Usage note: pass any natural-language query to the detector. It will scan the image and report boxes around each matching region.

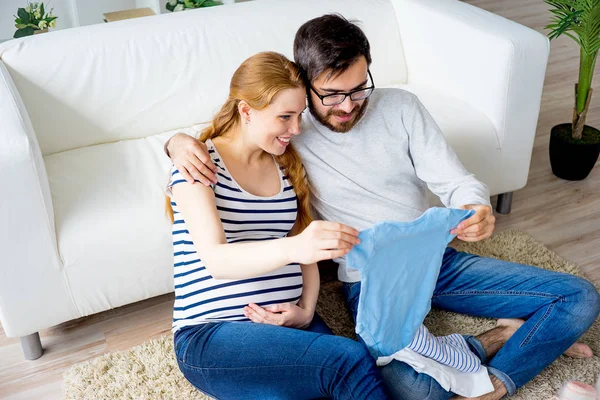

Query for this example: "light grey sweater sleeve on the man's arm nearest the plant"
[402,95,490,208]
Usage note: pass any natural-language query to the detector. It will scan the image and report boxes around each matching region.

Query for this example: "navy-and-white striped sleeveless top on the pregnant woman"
[167,140,302,332]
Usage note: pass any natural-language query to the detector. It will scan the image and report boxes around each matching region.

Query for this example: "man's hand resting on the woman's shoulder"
[165,133,217,186]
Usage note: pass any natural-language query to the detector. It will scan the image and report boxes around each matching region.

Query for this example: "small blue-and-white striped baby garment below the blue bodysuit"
[406,325,481,372]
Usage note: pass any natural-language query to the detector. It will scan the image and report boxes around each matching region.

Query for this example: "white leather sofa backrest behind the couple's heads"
[0,0,406,155]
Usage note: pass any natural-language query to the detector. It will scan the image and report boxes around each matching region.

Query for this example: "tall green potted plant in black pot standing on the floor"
[545,0,600,180]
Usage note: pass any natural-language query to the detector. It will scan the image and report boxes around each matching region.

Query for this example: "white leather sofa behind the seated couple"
[0,0,549,358]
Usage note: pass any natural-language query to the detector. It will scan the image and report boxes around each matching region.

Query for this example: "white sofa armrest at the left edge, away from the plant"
[0,61,78,337]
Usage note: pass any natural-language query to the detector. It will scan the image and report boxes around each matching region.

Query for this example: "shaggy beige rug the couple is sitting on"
[64,231,600,400]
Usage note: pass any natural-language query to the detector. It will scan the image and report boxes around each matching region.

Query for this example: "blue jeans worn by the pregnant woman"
[175,314,391,400]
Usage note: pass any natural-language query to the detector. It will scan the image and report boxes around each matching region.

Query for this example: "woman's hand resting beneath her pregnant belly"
[244,303,314,329]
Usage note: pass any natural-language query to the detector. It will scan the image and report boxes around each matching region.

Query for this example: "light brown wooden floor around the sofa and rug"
[0,0,600,399]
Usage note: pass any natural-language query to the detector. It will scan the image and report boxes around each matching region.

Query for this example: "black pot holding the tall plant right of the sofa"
[550,124,600,181]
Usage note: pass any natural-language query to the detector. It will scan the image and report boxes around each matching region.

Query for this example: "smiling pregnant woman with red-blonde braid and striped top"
[167,53,387,399]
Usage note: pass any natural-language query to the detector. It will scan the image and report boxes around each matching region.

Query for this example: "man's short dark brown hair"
[294,14,371,84]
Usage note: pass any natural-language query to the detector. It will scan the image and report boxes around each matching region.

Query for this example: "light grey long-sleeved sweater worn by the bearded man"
[293,89,490,282]
